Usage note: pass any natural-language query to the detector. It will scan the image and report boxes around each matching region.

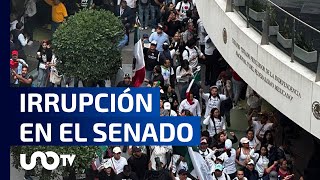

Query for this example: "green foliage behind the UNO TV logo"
[10,146,100,180]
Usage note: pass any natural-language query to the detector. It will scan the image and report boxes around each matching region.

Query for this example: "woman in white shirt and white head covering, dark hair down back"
[218,139,237,179]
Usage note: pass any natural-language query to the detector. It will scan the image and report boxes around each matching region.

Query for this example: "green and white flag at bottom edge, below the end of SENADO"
[173,146,212,180]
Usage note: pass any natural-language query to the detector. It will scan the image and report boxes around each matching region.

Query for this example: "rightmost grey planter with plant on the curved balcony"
[293,33,318,63]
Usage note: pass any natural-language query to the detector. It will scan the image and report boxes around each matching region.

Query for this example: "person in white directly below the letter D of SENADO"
[150,146,172,170]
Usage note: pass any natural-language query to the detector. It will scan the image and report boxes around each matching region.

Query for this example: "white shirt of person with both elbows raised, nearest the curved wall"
[202,93,227,118]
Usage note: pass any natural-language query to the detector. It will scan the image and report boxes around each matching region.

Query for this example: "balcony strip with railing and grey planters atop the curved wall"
[226,0,320,82]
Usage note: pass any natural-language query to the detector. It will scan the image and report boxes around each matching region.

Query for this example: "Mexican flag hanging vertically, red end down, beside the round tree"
[132,19,146,87]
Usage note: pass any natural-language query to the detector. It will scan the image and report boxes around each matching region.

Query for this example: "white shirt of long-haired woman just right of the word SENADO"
[203,116,226,137]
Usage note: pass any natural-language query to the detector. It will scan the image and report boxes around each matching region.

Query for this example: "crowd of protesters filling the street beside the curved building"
[10,0,300,180]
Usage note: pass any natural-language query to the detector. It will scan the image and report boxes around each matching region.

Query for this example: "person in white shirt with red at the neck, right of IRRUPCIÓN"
[179,91,201,117]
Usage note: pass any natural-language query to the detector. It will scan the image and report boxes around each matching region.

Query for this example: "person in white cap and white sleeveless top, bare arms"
[236,137,254,167]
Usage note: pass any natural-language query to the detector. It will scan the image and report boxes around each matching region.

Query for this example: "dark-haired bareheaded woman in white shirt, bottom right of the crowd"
[251,146,277,179]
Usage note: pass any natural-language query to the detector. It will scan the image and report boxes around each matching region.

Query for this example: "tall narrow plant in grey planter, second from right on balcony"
[277,18,292,48]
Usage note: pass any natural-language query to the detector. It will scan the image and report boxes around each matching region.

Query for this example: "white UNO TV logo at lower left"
[20,151,76,170]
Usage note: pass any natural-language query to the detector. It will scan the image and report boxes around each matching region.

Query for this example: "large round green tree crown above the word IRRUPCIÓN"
[53,9,124,81]
